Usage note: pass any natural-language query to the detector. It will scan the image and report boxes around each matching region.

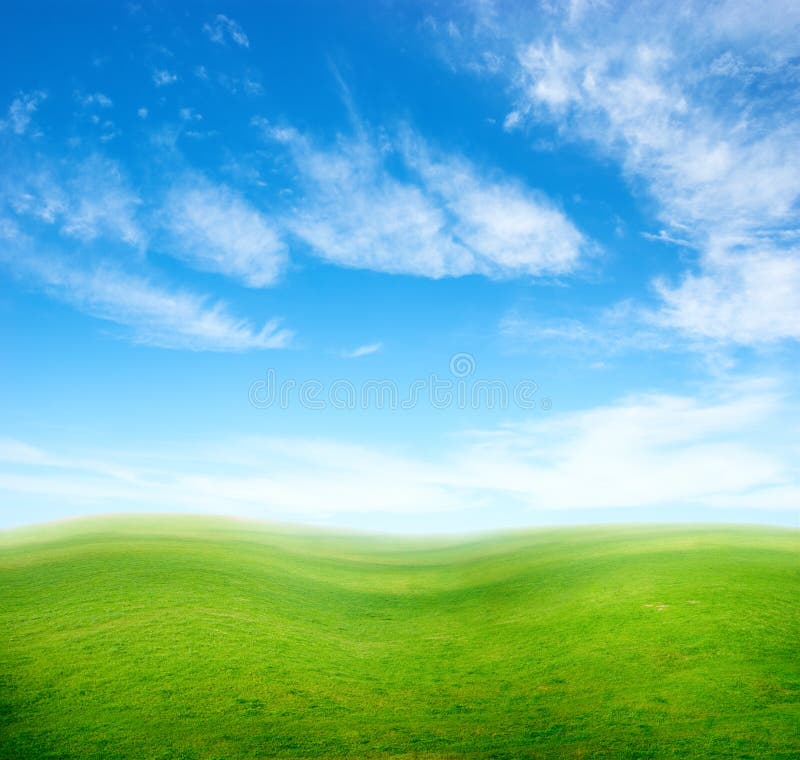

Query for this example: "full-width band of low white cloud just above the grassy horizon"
[0,382,800,530]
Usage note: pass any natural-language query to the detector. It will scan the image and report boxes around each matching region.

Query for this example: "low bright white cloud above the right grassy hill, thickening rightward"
[444,388,800,510]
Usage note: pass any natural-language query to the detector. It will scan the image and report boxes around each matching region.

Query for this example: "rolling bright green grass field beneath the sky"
[0,517,800,760]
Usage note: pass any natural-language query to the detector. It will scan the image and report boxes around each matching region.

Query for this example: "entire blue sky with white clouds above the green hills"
[0,0,800,531]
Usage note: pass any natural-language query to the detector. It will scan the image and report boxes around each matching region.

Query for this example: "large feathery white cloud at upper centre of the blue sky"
[256,120,590,278]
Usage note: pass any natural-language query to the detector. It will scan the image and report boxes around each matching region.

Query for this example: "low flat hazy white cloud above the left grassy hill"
[0,437,461,519]
